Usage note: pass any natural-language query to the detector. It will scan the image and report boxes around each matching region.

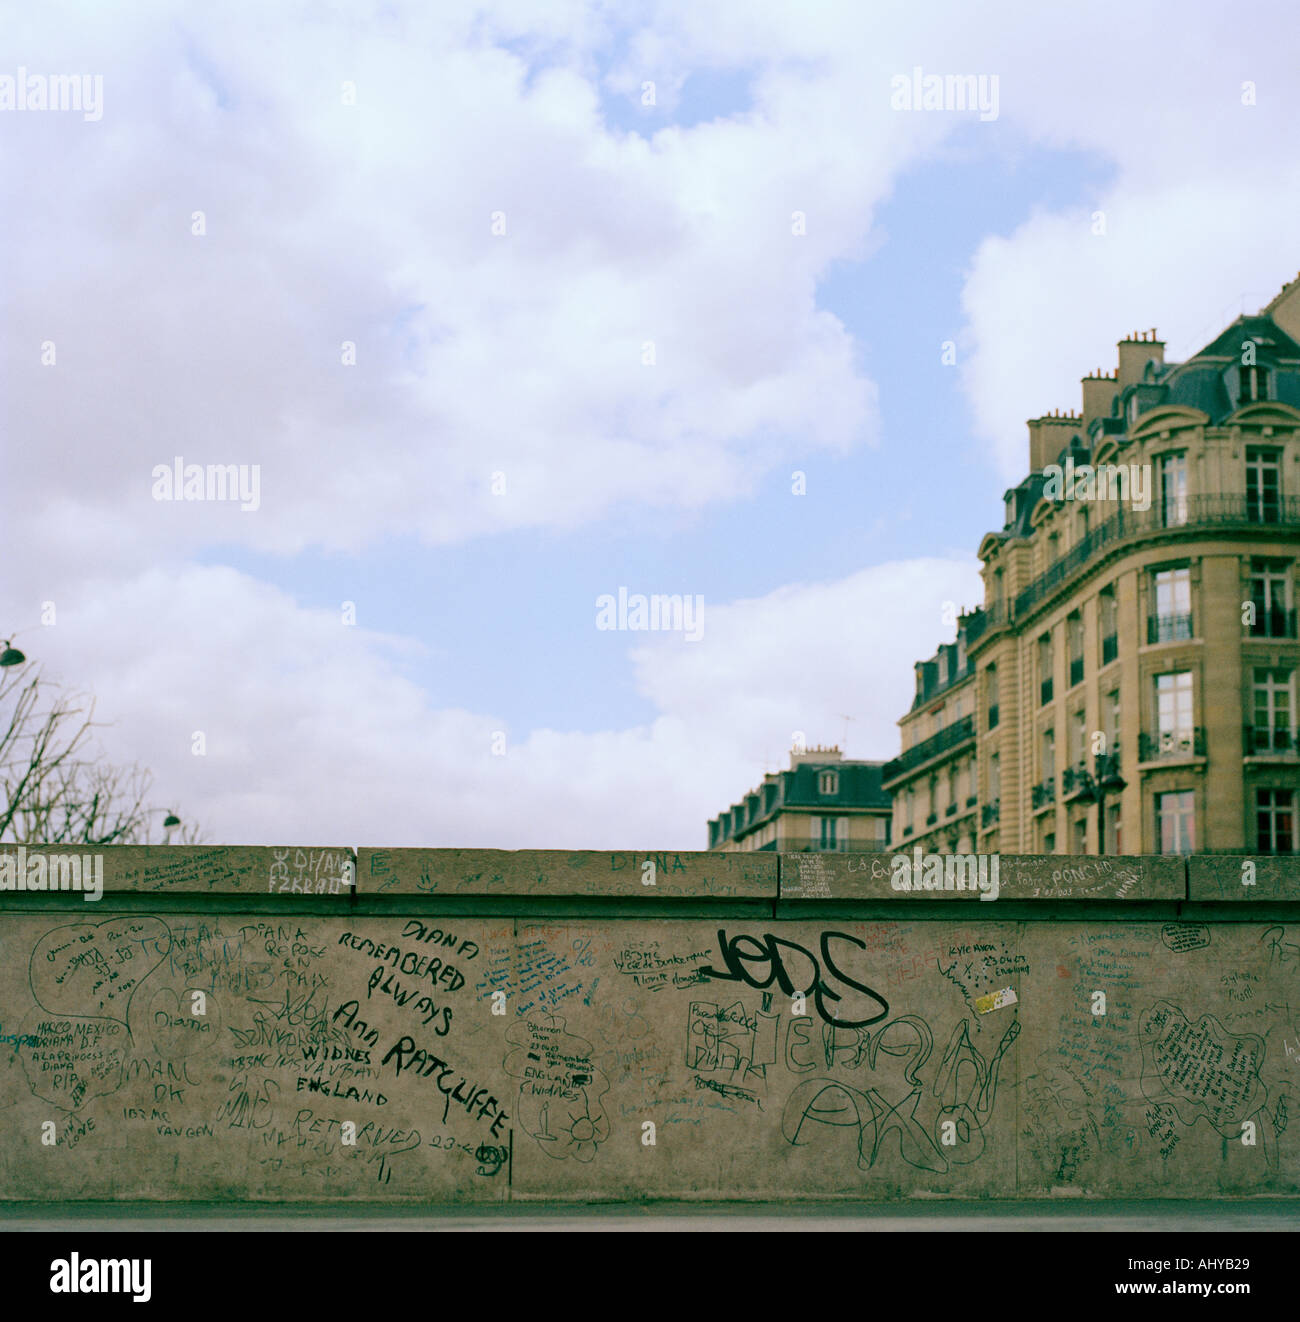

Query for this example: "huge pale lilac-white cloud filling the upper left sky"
[4,0,885,563]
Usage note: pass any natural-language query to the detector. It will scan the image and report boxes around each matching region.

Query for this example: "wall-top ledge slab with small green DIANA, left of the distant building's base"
[357,849,778,900]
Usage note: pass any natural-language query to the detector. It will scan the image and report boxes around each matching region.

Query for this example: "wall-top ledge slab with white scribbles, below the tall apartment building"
[780,850,1186,904]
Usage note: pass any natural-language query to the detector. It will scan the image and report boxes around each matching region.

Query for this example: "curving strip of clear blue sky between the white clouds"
[204,127,1110,740]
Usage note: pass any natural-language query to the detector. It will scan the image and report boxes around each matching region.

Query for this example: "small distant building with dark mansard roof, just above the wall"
[709,747,891,853]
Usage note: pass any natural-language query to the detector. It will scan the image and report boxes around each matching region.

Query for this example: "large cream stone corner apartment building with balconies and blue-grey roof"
[882,278,1300,854]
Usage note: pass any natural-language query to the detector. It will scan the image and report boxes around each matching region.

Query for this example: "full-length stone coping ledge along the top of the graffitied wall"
[0,845,1300,907]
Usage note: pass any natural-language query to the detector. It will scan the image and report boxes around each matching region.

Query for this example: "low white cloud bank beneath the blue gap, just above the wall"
[0,559,979,849]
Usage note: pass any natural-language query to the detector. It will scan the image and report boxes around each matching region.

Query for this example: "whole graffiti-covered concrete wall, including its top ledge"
[0,846,1300,1203]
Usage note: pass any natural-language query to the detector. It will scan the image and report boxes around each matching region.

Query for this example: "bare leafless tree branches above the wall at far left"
[0,647,202,845]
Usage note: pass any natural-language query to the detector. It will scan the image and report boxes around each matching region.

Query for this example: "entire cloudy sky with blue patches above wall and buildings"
[10,0,1300,847]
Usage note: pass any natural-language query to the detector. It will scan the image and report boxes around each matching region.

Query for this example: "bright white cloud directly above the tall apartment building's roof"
[963,186,1300,481]
